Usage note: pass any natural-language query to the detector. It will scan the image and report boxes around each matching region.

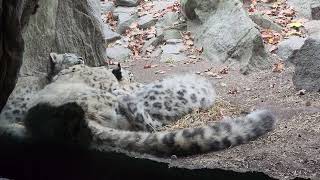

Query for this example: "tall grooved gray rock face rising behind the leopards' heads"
[20,0,106,76]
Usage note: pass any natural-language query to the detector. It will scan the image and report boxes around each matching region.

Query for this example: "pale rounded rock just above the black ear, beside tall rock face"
[107,46,131,62]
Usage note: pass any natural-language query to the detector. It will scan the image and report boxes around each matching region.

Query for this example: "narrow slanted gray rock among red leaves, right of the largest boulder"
[250,13,282,33]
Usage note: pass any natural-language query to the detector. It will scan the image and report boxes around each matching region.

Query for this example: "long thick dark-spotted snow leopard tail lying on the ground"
[89,110,276,156]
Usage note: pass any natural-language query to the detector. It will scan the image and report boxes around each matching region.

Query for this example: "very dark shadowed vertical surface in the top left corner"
[0,0,38,112]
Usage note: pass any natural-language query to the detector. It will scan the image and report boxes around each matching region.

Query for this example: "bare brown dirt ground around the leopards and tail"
[120,60,320,179]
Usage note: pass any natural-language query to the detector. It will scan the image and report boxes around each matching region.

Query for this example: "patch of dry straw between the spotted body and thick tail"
[160,100,246,131]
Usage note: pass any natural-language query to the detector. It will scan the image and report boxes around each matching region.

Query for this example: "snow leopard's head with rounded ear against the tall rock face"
[50,53,84,74]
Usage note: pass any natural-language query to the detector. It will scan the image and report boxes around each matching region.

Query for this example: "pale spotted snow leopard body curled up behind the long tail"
[119,75,216,131]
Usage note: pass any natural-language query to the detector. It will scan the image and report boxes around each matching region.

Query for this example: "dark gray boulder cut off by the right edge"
[289,33,320,92]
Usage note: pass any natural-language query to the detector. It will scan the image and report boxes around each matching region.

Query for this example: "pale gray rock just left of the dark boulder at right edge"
[276,36,306,61]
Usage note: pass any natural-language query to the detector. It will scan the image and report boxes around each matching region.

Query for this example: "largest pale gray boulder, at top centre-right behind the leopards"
[186,0,269,73]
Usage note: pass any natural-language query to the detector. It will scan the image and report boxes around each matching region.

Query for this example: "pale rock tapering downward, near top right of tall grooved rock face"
[113,7,138,34]
